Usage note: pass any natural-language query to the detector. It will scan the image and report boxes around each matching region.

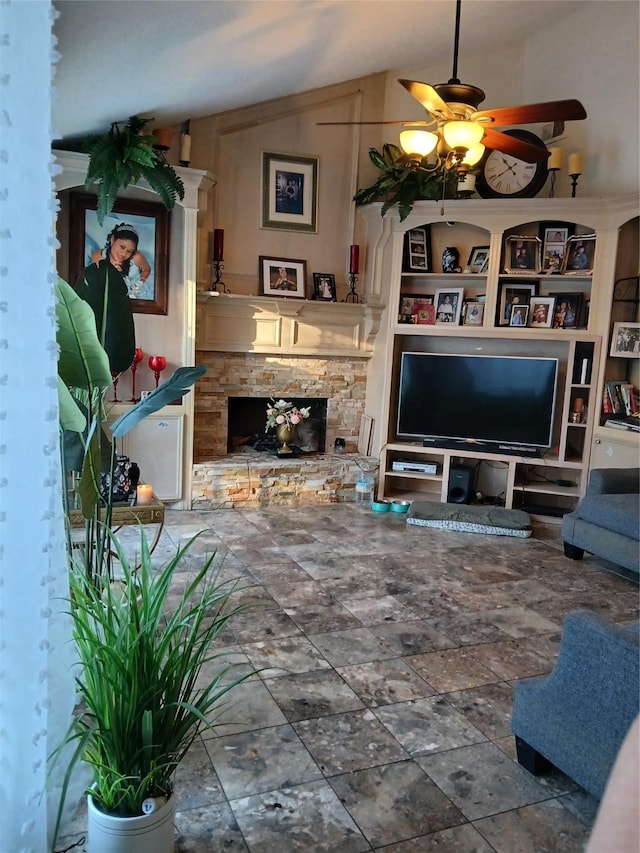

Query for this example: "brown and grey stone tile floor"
[58,503,638,853]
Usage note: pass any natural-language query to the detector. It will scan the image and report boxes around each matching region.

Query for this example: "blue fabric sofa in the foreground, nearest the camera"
[511,610,640,798]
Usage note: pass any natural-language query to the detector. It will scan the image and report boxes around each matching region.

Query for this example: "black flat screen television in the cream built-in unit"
[396,352,558,453]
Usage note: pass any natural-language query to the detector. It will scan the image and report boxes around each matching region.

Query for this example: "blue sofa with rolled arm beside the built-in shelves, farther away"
[562,468,640,573]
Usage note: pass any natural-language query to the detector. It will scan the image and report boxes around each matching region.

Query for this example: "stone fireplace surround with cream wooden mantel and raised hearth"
[191,294,382,509]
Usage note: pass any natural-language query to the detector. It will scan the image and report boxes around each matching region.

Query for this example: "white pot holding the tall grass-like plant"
[87,791,176,853]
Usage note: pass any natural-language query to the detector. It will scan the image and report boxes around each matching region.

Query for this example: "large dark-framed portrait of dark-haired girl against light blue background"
[69,193,169,314]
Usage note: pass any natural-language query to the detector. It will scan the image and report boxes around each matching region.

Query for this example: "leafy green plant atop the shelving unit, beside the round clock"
[353,142,458,222]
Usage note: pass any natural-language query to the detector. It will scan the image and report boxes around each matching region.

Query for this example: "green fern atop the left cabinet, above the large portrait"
[84,116,184,225]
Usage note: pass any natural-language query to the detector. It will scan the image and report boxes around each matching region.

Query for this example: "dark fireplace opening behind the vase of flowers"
[227,397,327,454]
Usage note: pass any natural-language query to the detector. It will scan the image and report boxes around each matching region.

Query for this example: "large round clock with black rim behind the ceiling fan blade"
[476,128,549,198]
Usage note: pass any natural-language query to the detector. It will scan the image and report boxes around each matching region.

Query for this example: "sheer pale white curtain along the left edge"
[0,0,75,853]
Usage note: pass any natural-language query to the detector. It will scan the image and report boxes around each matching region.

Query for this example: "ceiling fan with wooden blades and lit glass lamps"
[319,0,587,168]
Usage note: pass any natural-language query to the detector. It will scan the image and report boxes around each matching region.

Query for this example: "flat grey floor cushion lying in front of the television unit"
[407,501,531,539]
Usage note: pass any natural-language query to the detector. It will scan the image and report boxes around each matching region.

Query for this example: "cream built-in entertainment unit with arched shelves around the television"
[359,196,638,515]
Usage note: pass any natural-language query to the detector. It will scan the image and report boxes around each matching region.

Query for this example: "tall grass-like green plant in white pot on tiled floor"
[54,529,252,853]
